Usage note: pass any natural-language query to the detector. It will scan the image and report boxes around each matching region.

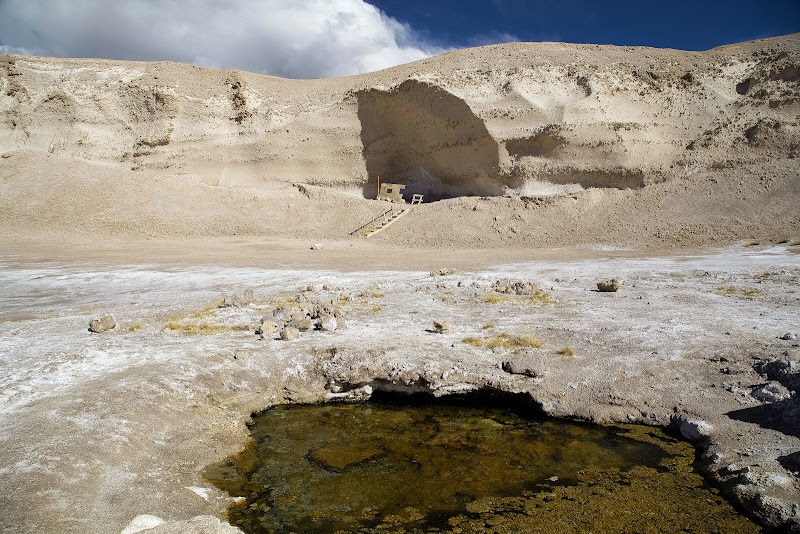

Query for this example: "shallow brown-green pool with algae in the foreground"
[205,396,760,534]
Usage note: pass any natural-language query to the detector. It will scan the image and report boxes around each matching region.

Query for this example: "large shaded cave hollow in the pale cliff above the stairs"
[356,80,520,201]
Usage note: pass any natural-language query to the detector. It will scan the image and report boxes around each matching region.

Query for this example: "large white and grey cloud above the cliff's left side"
[0,0,445,78]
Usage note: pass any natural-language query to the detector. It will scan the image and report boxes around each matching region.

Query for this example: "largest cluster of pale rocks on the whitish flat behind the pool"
[256,292,346,341]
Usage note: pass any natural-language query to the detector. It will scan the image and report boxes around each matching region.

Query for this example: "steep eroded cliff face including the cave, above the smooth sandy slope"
[0,34,800,241]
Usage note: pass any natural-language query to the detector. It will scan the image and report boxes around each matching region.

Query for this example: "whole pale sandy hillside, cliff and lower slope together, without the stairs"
[0,35,800,247]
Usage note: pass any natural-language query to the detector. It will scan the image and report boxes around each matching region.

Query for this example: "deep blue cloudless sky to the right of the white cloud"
[370,0,800,50]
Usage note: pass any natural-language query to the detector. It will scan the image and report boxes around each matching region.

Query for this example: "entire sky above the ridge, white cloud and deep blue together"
[0,0,800,78]
